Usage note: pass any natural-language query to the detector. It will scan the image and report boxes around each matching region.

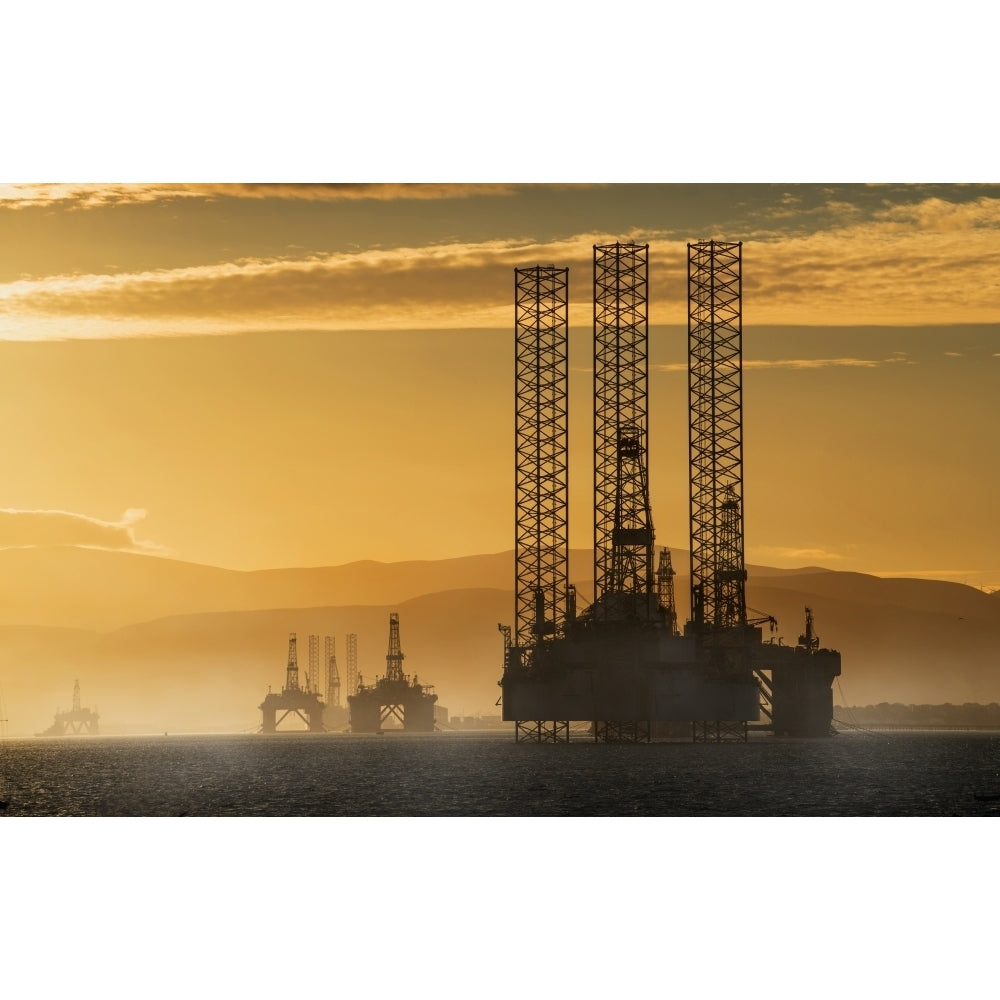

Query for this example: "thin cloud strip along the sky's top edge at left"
[0,184,515,209]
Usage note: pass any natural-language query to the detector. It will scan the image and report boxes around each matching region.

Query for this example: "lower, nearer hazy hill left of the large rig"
[0,589,513,735]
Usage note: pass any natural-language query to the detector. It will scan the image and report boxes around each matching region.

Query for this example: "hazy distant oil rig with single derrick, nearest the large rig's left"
[347,612,437,733]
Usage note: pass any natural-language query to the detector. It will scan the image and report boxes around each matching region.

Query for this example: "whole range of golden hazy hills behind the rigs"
[0,549,1000,735]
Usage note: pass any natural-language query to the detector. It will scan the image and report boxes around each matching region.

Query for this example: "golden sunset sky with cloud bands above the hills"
[0,183,1000,585]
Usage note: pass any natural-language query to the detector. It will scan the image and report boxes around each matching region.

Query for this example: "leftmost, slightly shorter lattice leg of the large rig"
[514,267,569,650]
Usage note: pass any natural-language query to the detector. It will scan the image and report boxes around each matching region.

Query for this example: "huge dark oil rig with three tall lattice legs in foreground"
[498,240,840,743]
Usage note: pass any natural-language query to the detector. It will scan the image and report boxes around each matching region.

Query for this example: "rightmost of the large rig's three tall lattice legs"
[688,240,747,630]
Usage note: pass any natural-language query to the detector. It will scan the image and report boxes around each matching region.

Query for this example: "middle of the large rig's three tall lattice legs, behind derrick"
[594,243,656,621]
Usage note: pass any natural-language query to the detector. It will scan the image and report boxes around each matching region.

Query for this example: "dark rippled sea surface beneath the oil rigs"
[0,732,1000,817]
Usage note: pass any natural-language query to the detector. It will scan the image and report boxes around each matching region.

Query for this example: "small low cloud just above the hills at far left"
[0,508,165,554]
